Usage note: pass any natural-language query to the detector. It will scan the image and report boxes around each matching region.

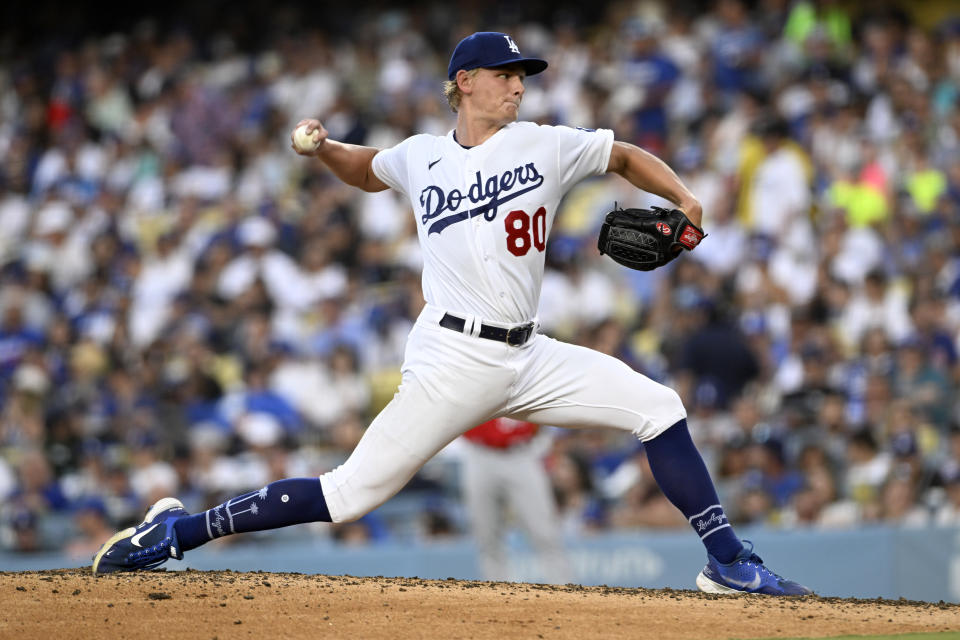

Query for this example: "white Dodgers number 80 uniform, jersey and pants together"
[320,122,686,522]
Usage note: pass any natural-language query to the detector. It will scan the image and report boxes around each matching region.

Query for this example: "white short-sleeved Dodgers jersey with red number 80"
[373,122,613,323]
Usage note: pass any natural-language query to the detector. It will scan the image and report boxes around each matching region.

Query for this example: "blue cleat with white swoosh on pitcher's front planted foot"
[697,540,813,596]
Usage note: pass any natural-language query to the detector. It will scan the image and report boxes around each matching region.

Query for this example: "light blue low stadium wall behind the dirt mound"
[0,526,960,604]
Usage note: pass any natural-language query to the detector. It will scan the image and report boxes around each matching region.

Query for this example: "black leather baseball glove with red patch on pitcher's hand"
[597,207,705,271]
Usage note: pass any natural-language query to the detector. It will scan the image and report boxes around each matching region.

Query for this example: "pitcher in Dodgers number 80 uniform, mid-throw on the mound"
[93,32,811,595]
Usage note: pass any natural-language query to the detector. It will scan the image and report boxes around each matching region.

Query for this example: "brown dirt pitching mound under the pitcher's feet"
[0,570,960,640]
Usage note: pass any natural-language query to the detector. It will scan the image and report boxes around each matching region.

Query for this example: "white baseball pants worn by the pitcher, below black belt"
[320,305,686,522]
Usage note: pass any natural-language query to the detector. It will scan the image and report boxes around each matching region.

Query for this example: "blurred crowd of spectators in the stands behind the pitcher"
[0,0,960,559]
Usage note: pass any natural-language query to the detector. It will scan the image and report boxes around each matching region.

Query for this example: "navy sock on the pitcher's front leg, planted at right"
[643,420,743,564]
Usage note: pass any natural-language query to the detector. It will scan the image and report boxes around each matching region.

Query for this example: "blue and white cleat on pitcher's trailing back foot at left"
[93,498,189,574]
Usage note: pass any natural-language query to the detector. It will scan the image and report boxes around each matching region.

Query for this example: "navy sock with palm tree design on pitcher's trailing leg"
[173,478,331,551]
